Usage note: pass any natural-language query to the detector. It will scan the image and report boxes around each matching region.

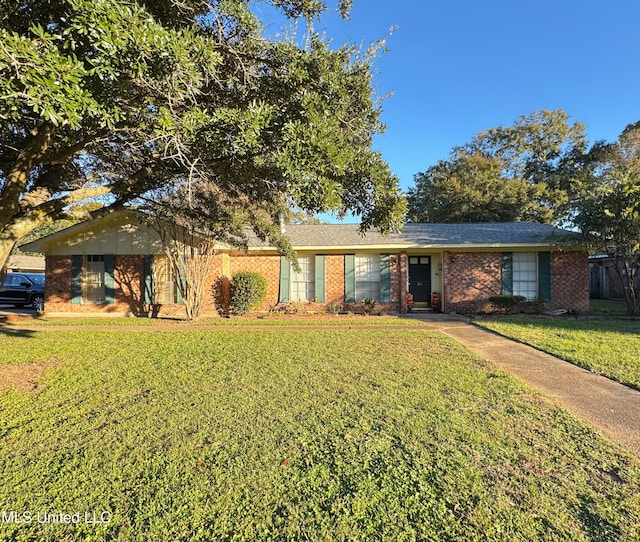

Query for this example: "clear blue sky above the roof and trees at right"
[255,0,640,200]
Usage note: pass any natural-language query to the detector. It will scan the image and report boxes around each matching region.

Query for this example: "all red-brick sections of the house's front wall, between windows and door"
[45,251,589,316]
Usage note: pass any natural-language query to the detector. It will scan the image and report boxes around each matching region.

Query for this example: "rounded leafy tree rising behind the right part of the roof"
[408,110,586,223]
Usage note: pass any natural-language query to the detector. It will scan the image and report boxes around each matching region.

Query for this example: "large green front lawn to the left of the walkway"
[0,327,640,542]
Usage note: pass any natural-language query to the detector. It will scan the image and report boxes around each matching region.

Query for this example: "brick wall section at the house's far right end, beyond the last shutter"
[551,251,589,312]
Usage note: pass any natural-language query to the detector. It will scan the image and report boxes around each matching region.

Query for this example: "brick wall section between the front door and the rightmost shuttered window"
[442,252,502,312]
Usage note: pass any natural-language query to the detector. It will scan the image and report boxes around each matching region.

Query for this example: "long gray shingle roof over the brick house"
[249,222,577,249]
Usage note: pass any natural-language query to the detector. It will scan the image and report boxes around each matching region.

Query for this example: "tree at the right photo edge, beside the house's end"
[575,122,640,316]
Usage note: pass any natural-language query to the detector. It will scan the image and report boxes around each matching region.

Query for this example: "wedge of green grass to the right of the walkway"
[476,316,640,389]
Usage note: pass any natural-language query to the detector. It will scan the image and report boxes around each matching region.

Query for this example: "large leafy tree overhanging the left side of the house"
[0,0,404,268]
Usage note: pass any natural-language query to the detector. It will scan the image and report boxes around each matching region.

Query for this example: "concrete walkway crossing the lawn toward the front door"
[408,316,640,457]
